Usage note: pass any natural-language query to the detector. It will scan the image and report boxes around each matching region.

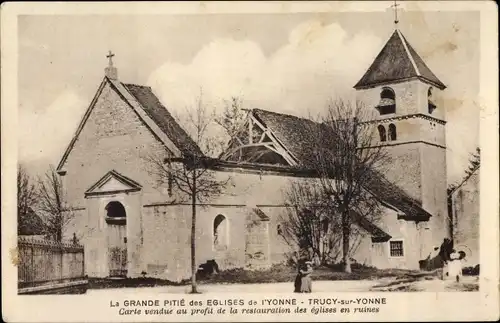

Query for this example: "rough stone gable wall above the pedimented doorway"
[63,83,167,207]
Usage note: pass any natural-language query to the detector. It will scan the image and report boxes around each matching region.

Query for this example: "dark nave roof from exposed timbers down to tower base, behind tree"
[252,109,431,219]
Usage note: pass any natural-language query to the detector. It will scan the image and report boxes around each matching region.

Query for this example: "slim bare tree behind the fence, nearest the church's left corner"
[38,165,73,242]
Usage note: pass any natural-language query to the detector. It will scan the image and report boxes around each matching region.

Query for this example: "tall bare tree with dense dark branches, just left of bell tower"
[309,99,389,272]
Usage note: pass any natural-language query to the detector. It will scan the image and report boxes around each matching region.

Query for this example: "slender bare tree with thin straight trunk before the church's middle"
[147,94,231,293]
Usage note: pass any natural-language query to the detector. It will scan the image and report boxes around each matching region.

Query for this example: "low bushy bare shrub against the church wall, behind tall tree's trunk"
[280,179,381,265]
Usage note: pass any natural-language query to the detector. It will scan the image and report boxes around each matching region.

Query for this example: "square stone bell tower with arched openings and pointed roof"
[354,25,449,253]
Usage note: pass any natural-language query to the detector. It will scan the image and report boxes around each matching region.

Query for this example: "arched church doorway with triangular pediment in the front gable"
[85,171,143,278]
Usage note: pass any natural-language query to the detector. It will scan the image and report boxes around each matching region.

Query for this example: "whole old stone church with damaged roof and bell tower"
[57,30,449,280]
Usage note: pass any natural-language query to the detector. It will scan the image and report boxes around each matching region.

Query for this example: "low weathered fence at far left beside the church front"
[17,237,85,288]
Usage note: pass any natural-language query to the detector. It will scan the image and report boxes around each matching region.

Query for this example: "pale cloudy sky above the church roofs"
[18,4,480,183]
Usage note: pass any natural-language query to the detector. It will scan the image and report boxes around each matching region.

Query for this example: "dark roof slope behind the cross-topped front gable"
[122,83,203,155]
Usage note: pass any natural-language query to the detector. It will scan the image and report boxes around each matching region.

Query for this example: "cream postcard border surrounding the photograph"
[1,1,499,322]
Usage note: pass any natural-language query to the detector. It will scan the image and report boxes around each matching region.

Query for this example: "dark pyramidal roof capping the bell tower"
[354,29,446,90]
